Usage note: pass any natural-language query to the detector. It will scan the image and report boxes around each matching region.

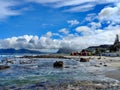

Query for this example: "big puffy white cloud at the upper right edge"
[99,3,120,23]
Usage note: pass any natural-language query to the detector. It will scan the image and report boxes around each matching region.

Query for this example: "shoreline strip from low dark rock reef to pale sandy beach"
[19,54,120,81]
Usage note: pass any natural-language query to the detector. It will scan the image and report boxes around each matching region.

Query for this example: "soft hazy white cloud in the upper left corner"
[0,0,19,19]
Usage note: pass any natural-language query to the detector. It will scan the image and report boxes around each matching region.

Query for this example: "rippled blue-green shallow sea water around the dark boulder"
[0,55,116,87]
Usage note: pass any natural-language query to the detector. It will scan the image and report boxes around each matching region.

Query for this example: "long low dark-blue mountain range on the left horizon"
[0,48,42,54]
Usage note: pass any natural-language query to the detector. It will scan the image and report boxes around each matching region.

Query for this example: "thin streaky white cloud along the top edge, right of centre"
[25,0,120,12]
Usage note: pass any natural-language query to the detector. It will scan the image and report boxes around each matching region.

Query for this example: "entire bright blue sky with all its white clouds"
[0,0,120,50]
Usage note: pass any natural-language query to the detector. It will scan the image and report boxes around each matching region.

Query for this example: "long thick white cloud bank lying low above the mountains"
[0,26,120,50]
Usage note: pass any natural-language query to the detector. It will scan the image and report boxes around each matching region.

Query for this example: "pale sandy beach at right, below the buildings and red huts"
[66,56,120,80]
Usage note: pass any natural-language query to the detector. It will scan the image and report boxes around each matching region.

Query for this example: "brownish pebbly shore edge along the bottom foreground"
[0,80,120,90]
